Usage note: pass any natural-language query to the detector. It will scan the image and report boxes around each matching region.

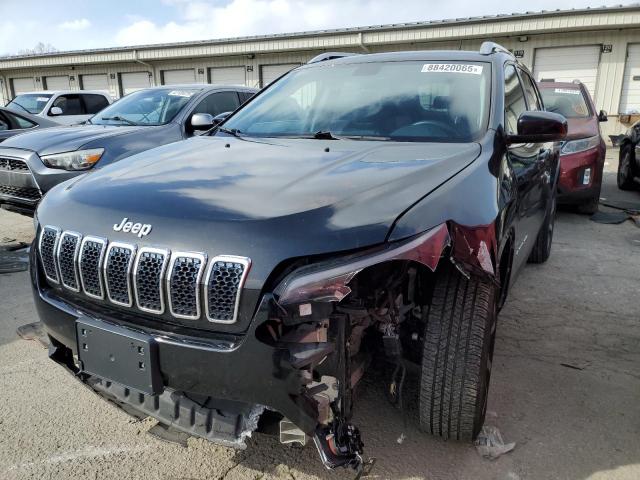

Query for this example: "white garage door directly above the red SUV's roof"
[533,45,600,97]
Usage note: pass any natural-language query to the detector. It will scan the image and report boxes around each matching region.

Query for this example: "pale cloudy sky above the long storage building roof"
[0,0,632,55]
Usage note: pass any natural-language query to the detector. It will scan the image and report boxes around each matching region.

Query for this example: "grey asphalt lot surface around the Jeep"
[0,152,640,480]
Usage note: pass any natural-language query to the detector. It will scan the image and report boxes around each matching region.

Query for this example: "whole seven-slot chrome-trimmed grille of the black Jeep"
[38,226,251,323]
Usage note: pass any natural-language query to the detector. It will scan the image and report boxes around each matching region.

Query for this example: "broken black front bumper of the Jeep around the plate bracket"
[31,244,338,466]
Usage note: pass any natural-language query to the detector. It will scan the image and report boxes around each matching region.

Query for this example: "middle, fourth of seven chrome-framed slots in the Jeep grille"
[104,242,136,307]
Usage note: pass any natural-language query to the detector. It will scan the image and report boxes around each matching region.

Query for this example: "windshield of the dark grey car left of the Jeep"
[91,88,198,125]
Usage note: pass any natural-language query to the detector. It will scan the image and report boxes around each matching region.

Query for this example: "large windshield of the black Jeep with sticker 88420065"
[223,61,491,142]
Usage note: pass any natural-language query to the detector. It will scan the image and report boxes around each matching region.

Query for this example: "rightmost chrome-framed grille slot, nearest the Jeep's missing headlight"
[204,256,249,323]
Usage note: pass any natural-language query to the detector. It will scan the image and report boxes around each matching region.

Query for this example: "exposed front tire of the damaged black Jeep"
[419,265,498,441]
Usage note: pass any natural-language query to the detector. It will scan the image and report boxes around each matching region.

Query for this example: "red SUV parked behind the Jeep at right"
[538,81,607,213]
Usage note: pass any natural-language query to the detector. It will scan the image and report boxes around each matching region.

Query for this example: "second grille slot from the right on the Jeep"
[167,252,206,320]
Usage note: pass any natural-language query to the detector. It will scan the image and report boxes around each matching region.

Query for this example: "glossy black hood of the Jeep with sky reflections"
[38,136,480,280]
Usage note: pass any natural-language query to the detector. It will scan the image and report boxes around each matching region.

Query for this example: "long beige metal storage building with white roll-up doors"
[0,4,640,139]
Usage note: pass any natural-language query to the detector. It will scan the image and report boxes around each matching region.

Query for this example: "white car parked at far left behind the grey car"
[7,90,113,125]
